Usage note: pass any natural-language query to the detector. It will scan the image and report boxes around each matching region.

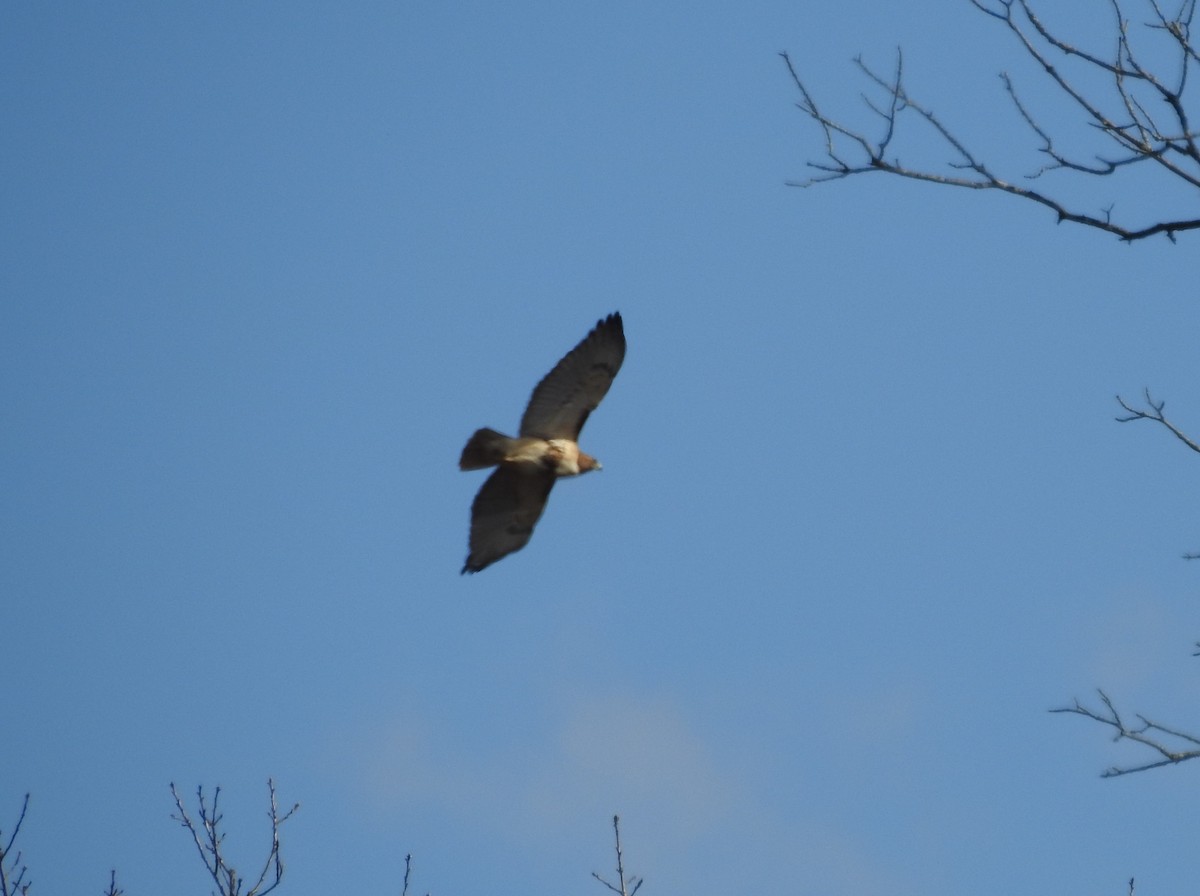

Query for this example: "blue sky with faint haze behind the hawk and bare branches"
[0,0,1200,896]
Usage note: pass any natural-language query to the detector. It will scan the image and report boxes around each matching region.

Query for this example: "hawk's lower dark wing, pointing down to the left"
[462,463,554,572]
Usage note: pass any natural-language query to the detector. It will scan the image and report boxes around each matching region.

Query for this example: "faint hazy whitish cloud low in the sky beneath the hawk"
[348,688,913,894]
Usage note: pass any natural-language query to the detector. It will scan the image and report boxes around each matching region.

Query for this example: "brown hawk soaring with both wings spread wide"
[458,313,625,572]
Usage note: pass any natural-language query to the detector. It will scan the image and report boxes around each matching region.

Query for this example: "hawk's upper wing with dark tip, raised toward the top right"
[521,313,625,441]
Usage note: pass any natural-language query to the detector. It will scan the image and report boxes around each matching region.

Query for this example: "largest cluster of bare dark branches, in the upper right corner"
[781,0,1200,241]
